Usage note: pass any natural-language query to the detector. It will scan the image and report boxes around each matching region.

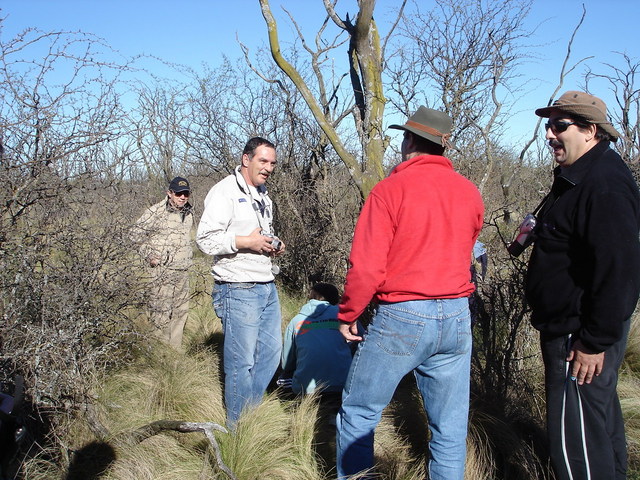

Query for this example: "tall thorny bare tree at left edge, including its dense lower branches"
[0,21,145,450]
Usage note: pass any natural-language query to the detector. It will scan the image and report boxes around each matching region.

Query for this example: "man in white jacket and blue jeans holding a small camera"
[196,137,284,428]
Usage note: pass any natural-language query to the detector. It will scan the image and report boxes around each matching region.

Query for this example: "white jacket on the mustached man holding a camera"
[196,167,274,282]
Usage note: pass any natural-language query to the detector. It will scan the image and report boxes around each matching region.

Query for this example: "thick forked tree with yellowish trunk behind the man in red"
[259,0,406,198]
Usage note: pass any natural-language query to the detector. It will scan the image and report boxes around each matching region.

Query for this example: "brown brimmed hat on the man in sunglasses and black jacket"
[536,90,620,142]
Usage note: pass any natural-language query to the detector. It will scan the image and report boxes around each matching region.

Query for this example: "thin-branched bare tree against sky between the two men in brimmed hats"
[390,0,531,197]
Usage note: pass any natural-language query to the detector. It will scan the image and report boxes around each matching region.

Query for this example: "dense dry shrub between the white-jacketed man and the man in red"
[270,152,360,295]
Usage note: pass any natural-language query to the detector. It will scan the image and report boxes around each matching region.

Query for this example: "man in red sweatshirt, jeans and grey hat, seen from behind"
[337,107,484,480]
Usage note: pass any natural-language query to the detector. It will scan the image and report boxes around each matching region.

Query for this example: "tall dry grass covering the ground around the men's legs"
[17,286,640,480]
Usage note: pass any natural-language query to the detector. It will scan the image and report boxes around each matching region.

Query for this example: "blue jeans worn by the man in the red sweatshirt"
[336,297,471,480]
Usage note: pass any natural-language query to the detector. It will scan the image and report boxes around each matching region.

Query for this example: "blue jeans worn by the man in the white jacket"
[212,282,282,429]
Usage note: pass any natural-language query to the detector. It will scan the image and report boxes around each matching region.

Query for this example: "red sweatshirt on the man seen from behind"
[338,155,484,323]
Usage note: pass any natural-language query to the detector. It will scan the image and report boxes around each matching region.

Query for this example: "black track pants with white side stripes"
[540,321,631,480]
